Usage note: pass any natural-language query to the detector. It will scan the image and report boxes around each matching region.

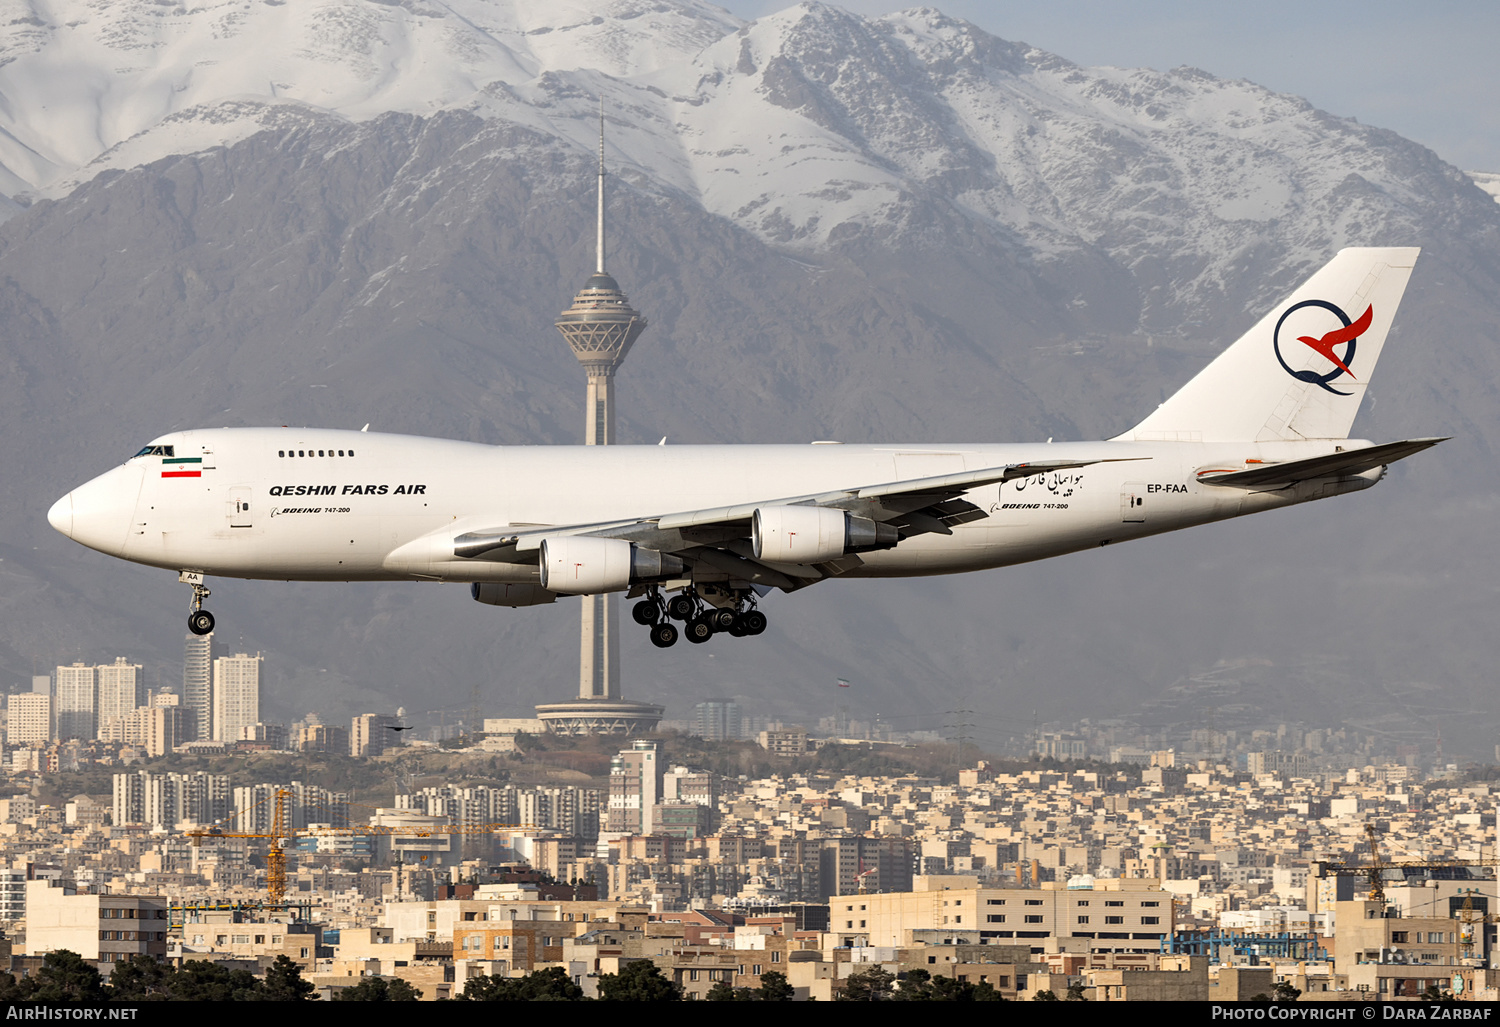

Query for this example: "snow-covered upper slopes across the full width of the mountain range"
[0,0,1494,322]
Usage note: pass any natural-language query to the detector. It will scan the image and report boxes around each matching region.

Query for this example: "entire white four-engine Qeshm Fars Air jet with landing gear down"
[48,249,1442,648]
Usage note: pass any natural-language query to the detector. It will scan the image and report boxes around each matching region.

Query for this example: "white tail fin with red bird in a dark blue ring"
[1118,247,1421,442]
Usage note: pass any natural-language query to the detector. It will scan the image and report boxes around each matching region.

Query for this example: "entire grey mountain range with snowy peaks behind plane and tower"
[0,0,1500,744]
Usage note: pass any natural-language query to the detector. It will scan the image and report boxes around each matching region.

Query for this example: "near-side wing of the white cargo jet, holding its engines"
[453,457,1131,591]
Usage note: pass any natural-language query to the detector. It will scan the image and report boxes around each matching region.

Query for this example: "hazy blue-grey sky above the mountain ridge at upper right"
[719,0,1500,171]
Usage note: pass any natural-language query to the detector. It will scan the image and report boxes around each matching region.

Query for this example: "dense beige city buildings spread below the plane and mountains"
[0,636,1500,1002]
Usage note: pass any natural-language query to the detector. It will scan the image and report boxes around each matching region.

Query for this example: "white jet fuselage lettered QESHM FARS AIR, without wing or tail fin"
[50,429,1380,583]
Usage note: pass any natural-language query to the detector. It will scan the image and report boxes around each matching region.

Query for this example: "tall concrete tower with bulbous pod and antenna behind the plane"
[537,103,665,735]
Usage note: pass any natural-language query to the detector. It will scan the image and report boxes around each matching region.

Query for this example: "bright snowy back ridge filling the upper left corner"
[0,0,738,192]
